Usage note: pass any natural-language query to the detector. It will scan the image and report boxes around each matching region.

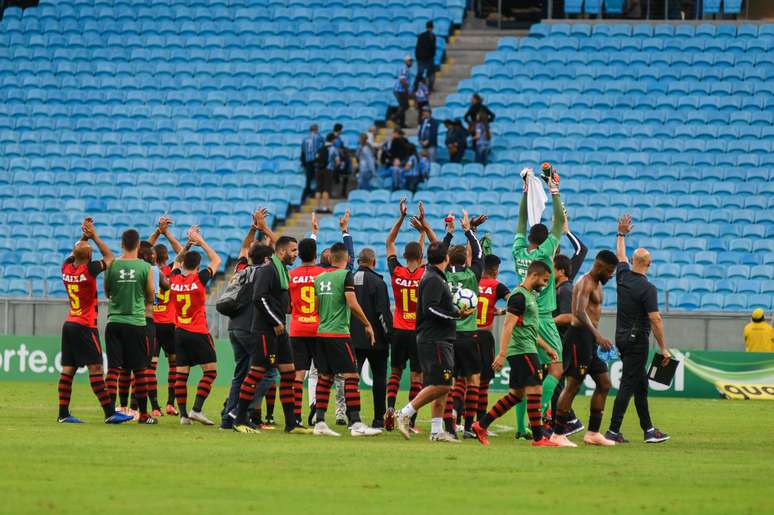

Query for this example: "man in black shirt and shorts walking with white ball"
[396,241,476,443]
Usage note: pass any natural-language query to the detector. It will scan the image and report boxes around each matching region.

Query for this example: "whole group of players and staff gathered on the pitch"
[58,169,669,447]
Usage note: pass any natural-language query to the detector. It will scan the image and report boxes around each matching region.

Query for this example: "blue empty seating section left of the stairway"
[0,0,464,295]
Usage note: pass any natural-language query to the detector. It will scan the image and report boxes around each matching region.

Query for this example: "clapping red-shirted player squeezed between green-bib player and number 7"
[148,216,183,416]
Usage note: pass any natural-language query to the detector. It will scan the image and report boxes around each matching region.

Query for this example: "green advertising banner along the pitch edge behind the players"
[0,336,774,400]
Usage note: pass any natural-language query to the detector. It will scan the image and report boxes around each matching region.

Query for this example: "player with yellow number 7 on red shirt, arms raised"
[170,227,221,426]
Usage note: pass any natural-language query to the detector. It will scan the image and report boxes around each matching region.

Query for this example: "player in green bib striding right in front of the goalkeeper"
[473,261,559,447]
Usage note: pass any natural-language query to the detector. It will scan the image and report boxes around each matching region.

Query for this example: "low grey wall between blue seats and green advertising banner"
[0,297,749,351]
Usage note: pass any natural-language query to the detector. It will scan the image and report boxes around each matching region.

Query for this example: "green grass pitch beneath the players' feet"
[0,382,774,515]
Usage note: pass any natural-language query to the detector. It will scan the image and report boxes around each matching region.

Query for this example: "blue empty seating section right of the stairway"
[334,23,774,311]
